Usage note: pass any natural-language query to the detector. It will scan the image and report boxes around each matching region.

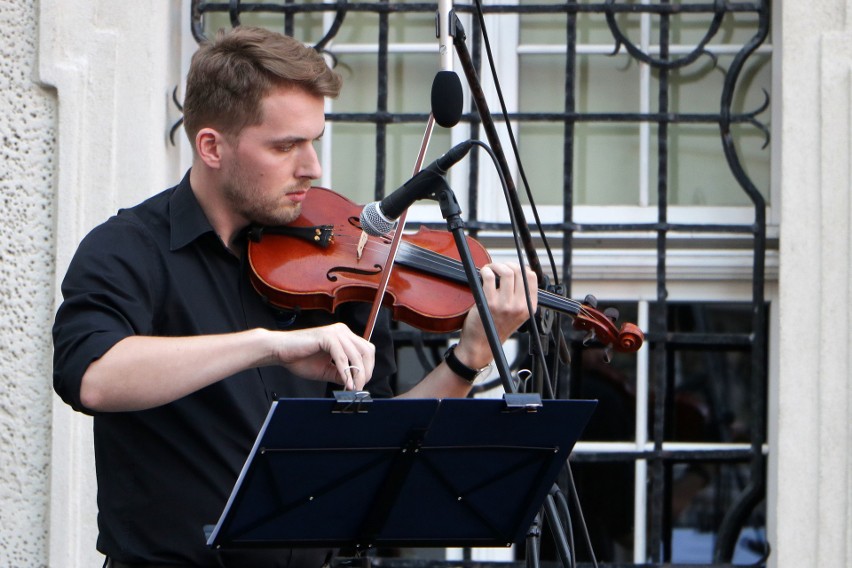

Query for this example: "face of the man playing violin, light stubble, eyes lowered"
[222,88,325,225]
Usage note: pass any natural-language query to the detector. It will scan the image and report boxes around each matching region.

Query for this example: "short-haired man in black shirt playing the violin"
[54,28,536,568]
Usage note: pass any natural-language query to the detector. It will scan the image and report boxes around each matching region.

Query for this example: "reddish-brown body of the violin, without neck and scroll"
[248,187,490,333]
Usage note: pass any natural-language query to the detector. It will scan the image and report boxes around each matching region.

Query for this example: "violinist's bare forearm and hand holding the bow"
[80,324,375,412]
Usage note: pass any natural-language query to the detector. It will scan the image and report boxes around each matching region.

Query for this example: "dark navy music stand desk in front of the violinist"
[206,394,597,550]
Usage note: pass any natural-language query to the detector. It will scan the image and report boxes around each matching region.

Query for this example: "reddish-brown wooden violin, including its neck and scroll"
[247,187,644,352]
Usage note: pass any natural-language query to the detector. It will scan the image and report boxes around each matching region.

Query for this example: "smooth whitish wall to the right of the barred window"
[769,0,852,566]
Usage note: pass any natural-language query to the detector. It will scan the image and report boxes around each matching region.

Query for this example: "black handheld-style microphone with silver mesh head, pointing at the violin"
[361,140,474,237]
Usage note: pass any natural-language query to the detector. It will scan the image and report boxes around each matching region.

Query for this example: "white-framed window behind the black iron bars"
[193,0,777,563]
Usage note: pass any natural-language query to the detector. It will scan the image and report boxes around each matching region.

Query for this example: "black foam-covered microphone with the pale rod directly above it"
[431,0,464,128]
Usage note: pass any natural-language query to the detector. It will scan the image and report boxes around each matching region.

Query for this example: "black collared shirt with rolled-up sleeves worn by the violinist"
[53,174,395,567]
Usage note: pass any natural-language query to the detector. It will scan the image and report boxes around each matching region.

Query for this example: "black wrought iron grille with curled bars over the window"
[192,0,770,566]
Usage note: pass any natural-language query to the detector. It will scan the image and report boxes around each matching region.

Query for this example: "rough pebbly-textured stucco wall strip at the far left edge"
[0,0,56,566]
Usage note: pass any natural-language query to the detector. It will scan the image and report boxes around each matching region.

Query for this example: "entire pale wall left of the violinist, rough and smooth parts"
[0,0,189,568]
